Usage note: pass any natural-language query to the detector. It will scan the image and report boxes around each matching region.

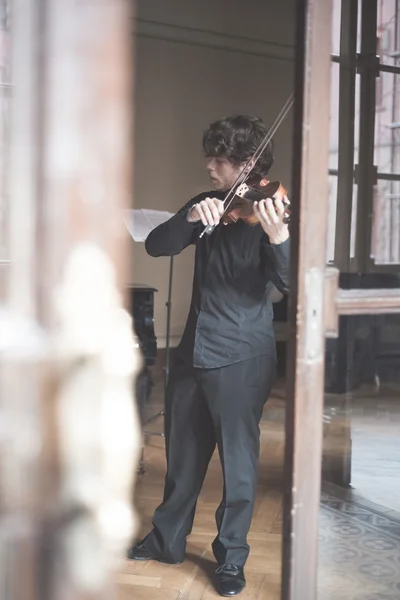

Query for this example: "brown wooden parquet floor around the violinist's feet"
[117,398,284,600]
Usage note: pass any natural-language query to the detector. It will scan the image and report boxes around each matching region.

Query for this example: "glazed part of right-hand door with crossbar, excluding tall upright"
[318,2,400,600]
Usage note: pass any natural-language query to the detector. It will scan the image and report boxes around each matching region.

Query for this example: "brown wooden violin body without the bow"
[222,178,290,225]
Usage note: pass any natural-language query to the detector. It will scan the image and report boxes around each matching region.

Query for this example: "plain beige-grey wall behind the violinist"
[132,0,295,347]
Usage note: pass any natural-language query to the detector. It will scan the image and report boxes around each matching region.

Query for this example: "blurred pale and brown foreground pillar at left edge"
[0,0,140,600]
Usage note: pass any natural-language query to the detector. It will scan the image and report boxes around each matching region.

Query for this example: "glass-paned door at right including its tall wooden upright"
[282,1,400,600]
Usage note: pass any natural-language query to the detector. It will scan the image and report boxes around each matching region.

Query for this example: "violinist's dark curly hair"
[203,115,274,177]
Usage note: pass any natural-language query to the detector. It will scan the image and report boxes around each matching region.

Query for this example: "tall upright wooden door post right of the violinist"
[282,0,332,600]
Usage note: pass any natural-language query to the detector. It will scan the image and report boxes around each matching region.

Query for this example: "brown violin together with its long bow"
[199,94,294,237]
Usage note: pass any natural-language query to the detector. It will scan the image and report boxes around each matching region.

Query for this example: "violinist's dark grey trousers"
[145,355,276,566]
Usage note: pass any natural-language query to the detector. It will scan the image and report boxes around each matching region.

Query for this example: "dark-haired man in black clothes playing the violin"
[128,115,290,596]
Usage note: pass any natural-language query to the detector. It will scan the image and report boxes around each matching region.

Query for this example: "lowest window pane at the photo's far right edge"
[371,180,400,265]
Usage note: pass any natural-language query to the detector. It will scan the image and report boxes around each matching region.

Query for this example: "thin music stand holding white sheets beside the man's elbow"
[125,209,174,437]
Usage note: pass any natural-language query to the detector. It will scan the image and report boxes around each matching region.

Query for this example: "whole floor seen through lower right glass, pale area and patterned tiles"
[318,385,400,600]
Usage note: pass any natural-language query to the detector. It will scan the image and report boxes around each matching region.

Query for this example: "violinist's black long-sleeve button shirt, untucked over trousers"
[145,192,290,368]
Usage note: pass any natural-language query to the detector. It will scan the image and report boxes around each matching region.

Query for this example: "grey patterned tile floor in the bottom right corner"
[318,494,400,600]
